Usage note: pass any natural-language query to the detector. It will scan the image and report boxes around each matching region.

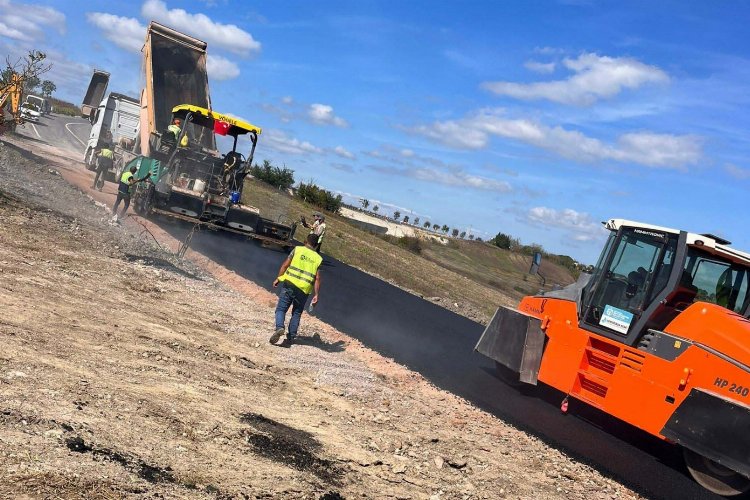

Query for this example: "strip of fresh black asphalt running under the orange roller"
[40,114,719,500]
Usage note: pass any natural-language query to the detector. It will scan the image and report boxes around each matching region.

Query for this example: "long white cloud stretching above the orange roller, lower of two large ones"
[408,109,702,168]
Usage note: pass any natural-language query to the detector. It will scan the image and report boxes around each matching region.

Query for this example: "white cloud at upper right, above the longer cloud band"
[482,53,669,106]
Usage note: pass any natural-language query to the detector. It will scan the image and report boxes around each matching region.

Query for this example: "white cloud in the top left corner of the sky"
[0,0,65,42]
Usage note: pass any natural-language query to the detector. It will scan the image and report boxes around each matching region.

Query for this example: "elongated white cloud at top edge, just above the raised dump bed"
[141,0,261,55]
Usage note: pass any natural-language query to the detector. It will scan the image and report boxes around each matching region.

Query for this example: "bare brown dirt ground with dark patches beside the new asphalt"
[0,136,639,500]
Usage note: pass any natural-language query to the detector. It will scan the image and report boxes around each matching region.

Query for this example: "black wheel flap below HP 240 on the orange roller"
[661,389,750,478]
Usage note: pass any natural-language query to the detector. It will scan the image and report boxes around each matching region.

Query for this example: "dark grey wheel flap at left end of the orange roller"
[474,306,544,385]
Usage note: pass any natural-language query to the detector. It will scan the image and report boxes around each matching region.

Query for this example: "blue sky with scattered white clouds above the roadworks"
[0,0,750,263]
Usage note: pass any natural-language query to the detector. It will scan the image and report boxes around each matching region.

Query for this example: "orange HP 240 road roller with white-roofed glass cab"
[475,219,750,496]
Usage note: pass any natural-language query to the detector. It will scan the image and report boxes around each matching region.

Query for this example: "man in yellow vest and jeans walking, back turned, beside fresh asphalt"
[269,233,323,346]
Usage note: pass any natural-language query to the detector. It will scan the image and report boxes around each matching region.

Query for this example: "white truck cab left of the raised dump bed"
[83,92,141,182]
